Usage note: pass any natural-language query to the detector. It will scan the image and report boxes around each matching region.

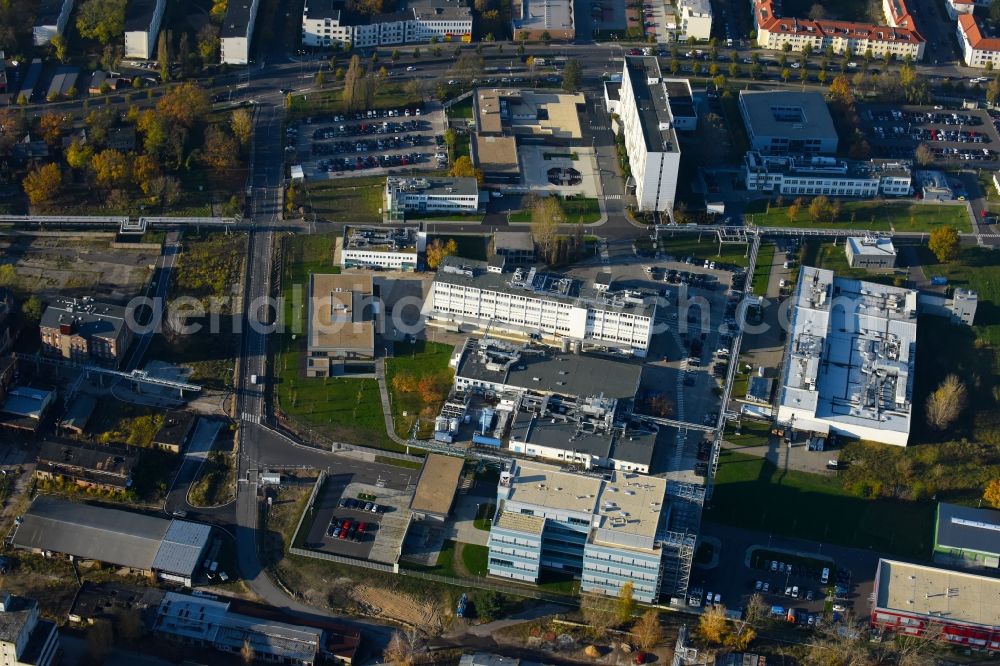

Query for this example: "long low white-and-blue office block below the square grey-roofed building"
[743,151,912,198]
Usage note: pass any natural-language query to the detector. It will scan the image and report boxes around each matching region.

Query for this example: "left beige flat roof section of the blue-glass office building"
[509,460,601,513]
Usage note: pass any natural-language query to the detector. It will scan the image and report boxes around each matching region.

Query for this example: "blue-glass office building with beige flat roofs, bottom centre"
[489,460,667,603]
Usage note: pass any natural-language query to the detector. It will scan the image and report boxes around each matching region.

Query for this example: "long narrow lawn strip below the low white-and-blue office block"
[748,199,971,232]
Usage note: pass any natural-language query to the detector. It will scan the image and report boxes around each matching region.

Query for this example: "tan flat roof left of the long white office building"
[308,273,375,354]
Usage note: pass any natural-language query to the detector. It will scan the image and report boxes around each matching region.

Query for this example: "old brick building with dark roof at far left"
[39,297,132,365]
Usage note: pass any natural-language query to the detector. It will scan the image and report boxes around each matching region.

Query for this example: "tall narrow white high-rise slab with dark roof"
[619,57,690,211]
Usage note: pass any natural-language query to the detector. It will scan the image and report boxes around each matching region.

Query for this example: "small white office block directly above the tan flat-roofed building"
[340,227,427,271]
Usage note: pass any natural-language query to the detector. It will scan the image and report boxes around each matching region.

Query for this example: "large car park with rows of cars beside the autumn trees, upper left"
[285,105,448,179]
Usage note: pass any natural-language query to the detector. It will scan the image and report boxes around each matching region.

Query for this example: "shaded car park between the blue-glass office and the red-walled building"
[689,523,878,627]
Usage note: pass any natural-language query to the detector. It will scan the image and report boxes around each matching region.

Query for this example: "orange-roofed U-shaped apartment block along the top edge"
[753,0,926,60]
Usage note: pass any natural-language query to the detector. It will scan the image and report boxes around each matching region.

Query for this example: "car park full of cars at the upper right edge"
[860,106,1000,167]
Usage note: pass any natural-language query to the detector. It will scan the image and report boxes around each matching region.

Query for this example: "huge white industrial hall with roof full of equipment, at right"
[778,266,917,446]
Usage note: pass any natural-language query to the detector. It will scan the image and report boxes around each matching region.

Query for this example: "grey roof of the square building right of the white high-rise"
[740,90,837,139]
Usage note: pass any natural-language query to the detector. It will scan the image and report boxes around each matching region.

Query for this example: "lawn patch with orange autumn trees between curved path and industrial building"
[385,340,454,438]
